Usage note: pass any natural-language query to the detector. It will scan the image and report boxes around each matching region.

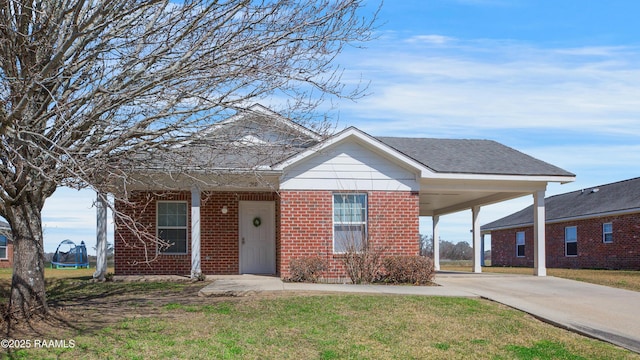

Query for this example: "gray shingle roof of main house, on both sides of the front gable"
[127,105,575,177]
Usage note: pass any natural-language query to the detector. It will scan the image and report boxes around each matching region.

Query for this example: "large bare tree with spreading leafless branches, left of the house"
[0,0,375,316]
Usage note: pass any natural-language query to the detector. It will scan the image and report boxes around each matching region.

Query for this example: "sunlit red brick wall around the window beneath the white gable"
[279,191,419,278]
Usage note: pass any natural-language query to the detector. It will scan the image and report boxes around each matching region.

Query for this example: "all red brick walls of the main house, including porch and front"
[115,191,419,278]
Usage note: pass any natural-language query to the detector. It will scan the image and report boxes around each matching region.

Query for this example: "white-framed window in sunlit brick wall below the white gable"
[333,194,367,253]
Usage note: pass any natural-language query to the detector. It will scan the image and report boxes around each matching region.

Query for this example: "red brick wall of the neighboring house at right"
[491,213,640,270]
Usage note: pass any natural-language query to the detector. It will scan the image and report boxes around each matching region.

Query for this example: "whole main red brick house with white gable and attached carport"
[114,105,574,278]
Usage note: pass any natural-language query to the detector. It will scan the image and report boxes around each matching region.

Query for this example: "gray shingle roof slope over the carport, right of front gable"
[377,137,575,176]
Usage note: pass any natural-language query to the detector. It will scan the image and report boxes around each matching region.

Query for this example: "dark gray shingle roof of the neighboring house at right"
[481,177,640,231]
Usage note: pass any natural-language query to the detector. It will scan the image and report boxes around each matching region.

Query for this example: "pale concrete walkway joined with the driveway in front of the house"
[199,272,640,353]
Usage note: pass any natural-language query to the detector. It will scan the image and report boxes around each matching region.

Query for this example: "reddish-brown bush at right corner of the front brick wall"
[382,256,435,285]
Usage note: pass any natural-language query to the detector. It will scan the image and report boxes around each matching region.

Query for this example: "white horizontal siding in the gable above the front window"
[280,142,420,191]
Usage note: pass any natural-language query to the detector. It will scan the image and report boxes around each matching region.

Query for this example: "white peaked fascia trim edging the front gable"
[272,127,431,176]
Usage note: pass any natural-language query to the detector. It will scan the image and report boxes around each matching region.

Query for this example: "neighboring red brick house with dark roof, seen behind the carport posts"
[481,178,640,270]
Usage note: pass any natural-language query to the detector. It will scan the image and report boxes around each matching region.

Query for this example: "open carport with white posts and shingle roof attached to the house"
[378,137,575,276]
